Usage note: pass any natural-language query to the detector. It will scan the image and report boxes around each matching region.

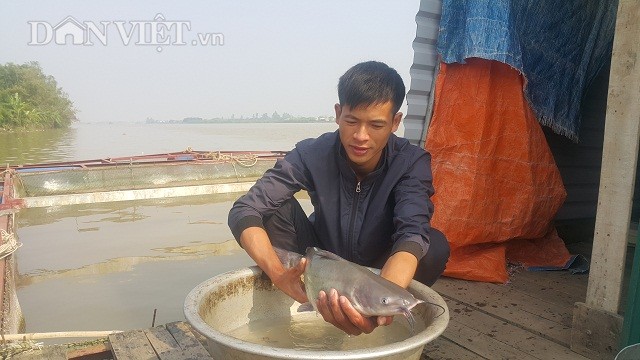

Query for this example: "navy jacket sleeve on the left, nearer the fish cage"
[228,149,309,241]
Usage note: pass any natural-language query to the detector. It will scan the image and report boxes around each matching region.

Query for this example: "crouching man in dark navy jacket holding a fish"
[229,61,449,335]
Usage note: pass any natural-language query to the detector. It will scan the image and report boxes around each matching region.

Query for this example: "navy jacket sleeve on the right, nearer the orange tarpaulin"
[392,152,434,260]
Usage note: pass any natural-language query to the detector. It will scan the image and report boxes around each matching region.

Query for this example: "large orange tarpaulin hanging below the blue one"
[426,59,570,282]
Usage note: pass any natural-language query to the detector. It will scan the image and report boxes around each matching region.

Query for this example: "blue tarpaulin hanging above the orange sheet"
[438,0,618,141]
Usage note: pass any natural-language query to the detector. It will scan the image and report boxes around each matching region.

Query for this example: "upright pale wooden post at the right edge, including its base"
[571,0,640,357]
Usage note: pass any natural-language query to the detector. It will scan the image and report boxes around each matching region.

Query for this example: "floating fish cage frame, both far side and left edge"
[0,150,285,334]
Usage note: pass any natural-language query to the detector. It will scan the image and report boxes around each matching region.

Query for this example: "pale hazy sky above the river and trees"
[0,0,420,122]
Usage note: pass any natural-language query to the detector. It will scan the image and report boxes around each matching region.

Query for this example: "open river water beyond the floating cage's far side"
[0,122,340,165]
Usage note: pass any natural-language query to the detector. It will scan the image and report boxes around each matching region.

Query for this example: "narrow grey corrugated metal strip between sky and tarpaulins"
[404,0,442,147]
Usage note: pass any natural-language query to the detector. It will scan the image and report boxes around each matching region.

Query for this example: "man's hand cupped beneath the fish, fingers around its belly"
[316,289,393,335]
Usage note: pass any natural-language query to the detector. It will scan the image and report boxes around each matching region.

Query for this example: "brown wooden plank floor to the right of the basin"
[423,240,588,360]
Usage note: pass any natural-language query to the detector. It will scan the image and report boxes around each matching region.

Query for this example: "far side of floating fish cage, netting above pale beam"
[6,151,284,207]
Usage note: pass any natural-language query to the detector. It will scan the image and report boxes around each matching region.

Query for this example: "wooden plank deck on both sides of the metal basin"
[10,243,590,360]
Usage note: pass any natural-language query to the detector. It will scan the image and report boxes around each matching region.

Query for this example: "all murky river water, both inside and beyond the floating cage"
[5,123,410,338]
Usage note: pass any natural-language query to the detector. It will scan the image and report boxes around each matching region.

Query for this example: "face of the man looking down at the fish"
[335,101,402,179]
